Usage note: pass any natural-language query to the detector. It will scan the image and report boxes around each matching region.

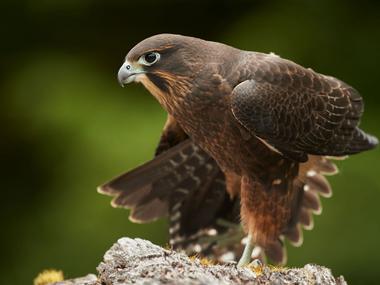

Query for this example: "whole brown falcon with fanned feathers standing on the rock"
[99,34,378,266]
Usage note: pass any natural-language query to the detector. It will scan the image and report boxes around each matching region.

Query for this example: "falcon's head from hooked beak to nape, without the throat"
[118,34,207,86]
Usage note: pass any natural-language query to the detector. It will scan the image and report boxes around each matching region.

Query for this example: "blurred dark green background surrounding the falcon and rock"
[0,0,380,284]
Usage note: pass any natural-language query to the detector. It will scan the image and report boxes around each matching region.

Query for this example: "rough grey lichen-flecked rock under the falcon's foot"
[55,238,347,285]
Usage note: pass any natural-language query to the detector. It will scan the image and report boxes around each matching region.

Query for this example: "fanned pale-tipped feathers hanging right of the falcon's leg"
[242,155,338,264]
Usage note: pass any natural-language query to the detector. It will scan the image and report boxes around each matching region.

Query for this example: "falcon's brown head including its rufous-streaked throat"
[118,34,230,109]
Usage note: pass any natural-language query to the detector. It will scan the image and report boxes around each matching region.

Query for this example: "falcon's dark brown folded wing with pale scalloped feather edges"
[231,55,377,161]
